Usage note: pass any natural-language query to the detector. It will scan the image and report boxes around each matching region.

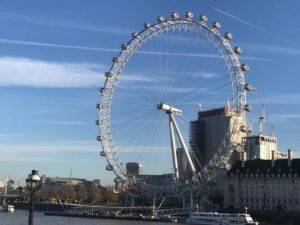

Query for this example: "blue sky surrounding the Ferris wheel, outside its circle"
[0,0,300,183]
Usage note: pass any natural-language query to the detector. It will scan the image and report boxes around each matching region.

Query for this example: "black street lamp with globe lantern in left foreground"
[26,170,42,225]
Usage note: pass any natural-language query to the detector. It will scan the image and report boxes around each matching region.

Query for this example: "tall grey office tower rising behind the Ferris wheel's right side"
[190,104,247,166]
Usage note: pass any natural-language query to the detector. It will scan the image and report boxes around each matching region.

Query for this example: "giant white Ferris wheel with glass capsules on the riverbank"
[96,12,251,196]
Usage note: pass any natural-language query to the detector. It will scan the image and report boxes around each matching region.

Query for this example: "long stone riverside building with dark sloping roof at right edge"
[224,152,300,212]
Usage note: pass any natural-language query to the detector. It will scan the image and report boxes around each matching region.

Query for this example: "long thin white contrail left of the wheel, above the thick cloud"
[0,38,120,52]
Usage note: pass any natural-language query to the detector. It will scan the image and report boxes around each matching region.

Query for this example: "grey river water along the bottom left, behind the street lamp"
[0,210,183,225]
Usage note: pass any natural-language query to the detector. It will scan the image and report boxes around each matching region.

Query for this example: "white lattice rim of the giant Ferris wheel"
[98,13,246,196]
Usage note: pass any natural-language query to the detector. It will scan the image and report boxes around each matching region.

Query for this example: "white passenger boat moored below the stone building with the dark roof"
[186,212,258,225]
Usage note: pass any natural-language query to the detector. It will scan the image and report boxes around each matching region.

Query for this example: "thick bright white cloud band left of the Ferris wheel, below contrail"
[0,57,104,88]
